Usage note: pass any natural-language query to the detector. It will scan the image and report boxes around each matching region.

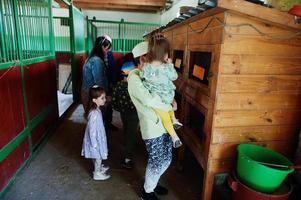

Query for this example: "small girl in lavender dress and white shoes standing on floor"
[81,85,110,180]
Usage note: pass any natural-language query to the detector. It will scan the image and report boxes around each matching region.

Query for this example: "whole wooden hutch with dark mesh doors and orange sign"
[162,0,301,200]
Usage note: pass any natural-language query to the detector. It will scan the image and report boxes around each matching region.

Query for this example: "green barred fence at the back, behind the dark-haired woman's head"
[87,19,159,53]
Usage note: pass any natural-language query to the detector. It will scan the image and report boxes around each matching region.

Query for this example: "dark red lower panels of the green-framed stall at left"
[0,60,58,193]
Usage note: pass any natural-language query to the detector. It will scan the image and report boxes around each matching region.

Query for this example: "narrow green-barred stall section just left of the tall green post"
[53,17,71,52]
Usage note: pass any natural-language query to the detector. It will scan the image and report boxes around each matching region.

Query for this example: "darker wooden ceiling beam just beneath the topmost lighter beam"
[74,3,160,12]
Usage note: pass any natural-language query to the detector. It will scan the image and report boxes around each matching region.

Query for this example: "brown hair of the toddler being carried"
[146,34,170,63]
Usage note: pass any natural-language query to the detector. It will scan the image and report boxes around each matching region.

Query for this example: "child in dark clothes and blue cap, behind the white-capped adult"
[112,55,139,169]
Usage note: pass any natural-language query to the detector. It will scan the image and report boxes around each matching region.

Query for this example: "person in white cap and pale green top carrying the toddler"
[128,42,176,200]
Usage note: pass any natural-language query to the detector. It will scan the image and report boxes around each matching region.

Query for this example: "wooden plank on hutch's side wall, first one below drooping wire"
[221,34,301,57]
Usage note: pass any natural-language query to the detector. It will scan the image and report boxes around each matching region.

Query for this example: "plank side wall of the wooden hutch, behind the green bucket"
[209,11,301,165]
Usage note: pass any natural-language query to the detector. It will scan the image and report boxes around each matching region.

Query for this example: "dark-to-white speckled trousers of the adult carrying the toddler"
[144,134,172,193]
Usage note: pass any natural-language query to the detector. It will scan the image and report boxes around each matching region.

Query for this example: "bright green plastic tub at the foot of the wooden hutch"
[237,144,293,193]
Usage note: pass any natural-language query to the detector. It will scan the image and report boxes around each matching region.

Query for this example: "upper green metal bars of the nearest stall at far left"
[0,0,53,67]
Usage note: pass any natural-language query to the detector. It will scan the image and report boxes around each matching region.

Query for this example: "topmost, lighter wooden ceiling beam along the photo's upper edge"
[73,0,166,7]
